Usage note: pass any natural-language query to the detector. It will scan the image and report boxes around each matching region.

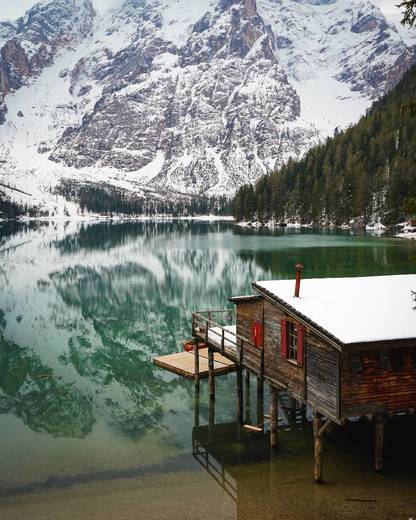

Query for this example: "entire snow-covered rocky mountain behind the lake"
[0,0,416,211]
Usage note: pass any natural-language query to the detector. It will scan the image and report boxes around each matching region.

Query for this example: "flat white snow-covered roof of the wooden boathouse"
[254,274,416,343]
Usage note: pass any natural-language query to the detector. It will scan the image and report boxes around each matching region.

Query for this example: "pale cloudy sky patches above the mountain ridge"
[0,0,404,21]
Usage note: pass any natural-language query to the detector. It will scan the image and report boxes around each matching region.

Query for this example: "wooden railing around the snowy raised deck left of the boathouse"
[192,309,255,364]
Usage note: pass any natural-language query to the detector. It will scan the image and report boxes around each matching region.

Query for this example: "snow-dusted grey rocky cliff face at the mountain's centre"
[51,0,316,193]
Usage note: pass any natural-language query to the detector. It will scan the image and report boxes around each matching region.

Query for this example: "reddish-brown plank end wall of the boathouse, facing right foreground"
[341,347,416,417]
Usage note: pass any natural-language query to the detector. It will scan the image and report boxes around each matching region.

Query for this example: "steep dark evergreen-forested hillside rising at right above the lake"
[234,67,416,225]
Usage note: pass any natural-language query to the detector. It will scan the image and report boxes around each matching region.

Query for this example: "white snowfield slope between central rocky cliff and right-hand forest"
[257,0,416,135]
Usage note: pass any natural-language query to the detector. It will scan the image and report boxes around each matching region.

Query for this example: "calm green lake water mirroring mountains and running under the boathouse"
[0,221,416,519]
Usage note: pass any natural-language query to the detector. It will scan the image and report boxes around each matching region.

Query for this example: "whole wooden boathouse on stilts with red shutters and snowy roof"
[154,265,416,483]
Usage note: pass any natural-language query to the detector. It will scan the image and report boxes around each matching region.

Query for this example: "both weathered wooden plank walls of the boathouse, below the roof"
[237,298,416,419]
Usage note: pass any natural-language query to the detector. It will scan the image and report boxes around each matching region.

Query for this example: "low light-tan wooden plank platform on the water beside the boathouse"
[153,348,236,379]
